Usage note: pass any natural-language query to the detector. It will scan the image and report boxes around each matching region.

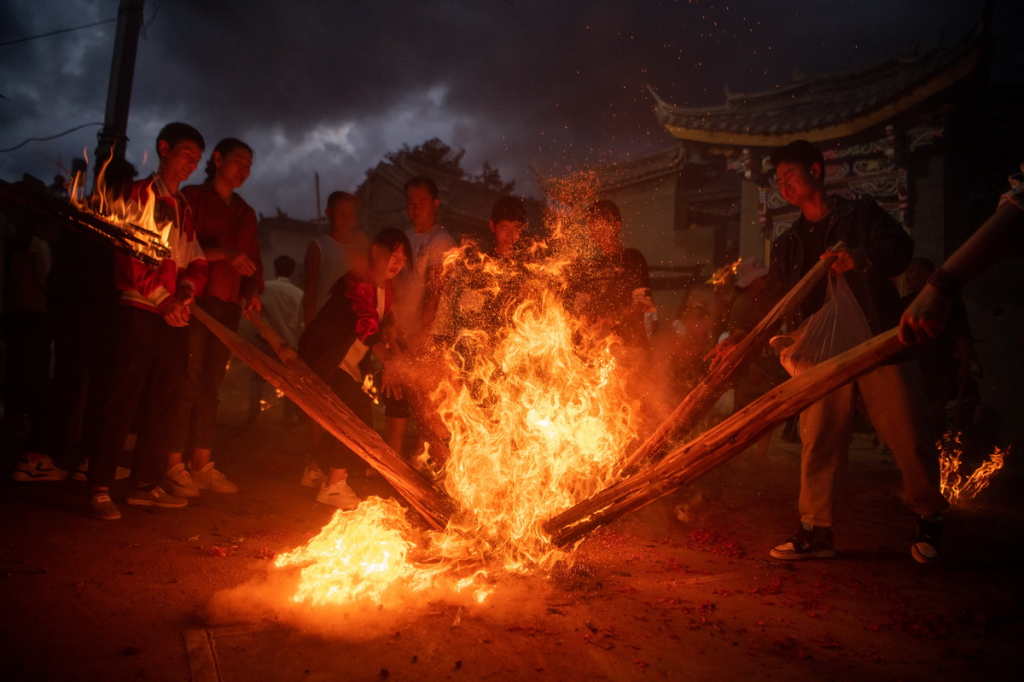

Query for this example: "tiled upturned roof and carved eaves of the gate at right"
[654,25,988,260]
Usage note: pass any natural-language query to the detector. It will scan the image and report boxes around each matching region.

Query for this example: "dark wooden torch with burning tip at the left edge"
[0,175,171,266]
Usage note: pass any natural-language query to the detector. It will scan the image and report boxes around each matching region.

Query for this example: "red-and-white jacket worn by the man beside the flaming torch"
[114,175,208,312]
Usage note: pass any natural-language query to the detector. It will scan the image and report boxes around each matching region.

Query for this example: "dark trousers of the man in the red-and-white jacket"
[85,305,188,485]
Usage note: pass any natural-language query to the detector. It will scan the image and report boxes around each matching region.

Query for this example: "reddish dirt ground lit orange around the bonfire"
[0,366,1024,682]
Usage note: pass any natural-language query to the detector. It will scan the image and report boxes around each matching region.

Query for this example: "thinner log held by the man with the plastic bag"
[618,242,845,473]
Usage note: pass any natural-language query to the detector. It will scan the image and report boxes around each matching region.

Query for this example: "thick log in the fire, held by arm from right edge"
[544,329,905,545]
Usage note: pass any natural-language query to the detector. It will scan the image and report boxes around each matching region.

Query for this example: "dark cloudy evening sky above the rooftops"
[0,0,1024,219]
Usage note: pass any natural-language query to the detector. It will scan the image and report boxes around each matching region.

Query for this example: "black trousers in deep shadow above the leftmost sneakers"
[26,300,119,466]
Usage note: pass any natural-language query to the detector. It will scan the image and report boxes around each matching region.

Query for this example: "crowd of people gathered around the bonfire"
[0,123,1021,561]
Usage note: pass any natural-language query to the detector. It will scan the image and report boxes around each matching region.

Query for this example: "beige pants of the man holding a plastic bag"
[800,360,949,526]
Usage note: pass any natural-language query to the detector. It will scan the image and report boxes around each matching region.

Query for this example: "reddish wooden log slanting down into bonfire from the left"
[191,305,450,530]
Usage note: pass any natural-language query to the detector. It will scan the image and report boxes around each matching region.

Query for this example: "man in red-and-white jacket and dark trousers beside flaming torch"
[85,123,208,520]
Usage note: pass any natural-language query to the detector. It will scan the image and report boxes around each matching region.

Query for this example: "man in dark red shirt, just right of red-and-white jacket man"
[163,137,263,498]
